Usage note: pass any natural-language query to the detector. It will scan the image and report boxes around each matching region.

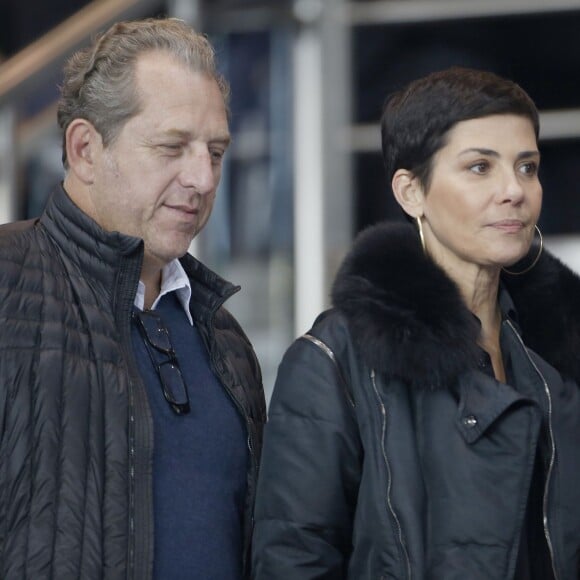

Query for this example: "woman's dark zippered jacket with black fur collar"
[253,224,580,580]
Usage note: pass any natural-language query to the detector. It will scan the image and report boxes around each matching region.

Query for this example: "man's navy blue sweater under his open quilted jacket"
[132,293,249,580]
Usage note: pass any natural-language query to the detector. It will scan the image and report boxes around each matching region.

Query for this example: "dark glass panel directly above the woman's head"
[353,10,580,123]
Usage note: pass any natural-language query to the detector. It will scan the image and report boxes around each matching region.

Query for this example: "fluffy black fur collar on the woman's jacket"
[332,223,580,388]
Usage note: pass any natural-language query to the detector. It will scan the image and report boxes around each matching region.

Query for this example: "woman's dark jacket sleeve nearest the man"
[253,324,362,580]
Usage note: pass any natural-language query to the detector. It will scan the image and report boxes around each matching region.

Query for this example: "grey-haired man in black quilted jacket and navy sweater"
[0,19,265,580]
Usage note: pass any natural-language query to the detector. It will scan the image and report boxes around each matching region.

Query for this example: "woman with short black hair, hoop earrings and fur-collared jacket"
[254,68,580,580]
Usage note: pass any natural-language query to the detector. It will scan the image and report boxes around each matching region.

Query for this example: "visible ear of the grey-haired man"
[66,119,103,185]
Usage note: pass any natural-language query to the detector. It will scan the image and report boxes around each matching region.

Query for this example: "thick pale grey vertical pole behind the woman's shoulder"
[294,0,353,334]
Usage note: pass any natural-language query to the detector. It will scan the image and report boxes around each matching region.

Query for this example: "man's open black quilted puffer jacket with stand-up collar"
[0,190,265,580]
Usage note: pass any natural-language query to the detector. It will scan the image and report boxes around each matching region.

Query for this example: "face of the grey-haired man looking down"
[83,52,230,268]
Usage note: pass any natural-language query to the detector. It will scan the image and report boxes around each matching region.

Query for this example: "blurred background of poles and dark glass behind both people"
[0,0,580,402]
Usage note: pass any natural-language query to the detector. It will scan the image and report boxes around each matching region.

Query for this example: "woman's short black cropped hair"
[381,67,539,189]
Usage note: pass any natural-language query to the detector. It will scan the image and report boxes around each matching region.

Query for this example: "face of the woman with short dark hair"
[422,114,542,276]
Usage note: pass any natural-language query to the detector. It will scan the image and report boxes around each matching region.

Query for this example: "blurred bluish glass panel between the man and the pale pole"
[198,28,293,396]
